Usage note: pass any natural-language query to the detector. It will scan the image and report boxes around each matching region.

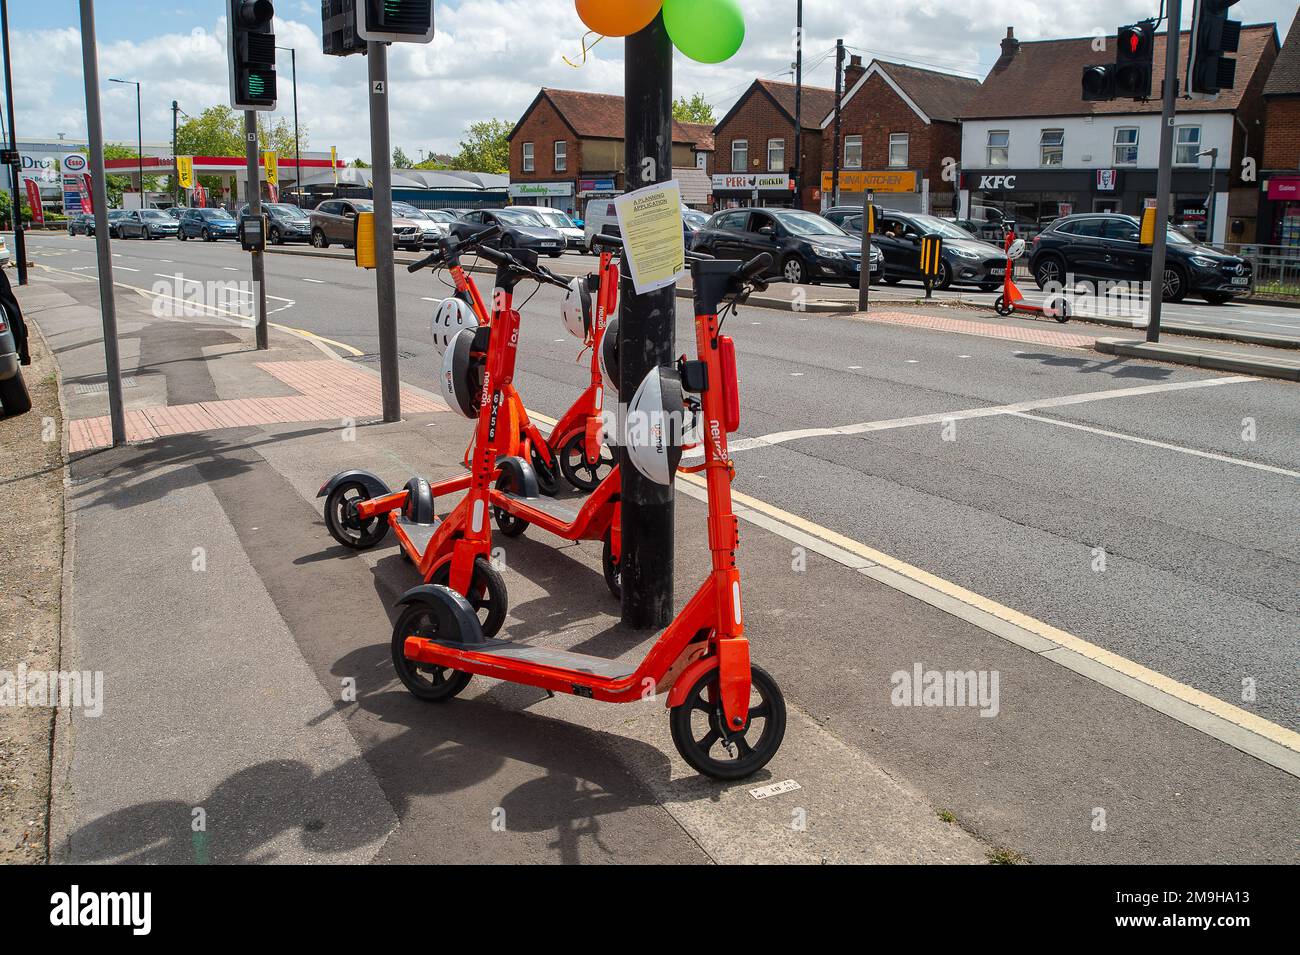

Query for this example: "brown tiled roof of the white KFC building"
[961,23,1277,120]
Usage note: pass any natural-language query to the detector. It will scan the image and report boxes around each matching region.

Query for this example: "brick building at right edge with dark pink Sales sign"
[1257,13,1300,249]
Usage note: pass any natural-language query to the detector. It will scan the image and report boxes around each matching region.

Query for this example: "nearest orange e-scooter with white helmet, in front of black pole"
[393,253,785,780]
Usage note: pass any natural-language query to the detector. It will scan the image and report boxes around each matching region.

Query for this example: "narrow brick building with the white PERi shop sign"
[714,79,835,210]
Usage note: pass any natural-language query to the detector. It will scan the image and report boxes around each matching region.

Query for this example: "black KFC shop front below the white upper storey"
[957,169,1229,240]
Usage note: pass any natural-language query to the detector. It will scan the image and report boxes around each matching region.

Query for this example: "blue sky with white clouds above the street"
[9,0,1296,159]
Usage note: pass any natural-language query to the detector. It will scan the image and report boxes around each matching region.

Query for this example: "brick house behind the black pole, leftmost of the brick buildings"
[510,87,712,217]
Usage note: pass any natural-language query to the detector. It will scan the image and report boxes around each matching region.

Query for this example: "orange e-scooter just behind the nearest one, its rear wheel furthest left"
[317,230,568,634]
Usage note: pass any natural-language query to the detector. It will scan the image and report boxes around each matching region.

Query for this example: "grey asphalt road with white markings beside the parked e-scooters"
[22,235,1300,729]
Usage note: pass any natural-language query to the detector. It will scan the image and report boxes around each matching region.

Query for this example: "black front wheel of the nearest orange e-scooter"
[668,667,785,780]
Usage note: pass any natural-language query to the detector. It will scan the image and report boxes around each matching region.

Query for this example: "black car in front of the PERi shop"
[692,209,880,286]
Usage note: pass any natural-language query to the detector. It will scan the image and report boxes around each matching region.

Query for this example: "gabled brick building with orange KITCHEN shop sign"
[820,56,979,216]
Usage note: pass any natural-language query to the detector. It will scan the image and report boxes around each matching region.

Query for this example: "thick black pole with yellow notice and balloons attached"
[619,13,677,629]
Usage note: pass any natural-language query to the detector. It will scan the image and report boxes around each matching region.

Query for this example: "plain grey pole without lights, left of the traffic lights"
[78,0,126,447]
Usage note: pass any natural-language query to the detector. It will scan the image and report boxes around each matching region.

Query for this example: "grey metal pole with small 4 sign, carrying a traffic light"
[365,40,397,421]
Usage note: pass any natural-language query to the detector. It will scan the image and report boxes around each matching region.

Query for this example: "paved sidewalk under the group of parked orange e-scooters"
[23,268,1300,863]
